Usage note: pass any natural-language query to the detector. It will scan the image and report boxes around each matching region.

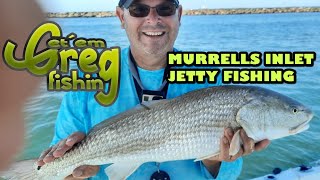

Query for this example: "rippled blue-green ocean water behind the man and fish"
[18,13,320,179]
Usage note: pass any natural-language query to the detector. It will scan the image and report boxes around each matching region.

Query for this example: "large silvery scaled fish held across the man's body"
[13,86,312,179]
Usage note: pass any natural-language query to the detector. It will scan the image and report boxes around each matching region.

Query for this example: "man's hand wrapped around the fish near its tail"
[37,132,99,180]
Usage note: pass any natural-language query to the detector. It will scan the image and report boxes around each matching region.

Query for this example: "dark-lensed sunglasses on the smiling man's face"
[128,2,178,17]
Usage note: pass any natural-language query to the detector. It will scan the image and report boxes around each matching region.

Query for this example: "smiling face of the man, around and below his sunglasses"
[117,0,182,55]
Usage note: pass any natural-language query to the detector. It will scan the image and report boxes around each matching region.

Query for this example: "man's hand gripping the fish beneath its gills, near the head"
[202,128,270,176]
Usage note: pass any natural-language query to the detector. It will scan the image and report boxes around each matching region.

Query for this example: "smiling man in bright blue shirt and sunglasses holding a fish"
[37,0,269,179]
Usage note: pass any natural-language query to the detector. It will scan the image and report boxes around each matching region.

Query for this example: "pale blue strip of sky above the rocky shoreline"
[38,0,320,12]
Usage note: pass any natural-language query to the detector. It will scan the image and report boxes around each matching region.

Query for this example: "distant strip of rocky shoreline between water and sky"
[47,7,320,18]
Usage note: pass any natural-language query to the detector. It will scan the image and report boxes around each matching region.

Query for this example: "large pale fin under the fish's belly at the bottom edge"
[104,162,142,180]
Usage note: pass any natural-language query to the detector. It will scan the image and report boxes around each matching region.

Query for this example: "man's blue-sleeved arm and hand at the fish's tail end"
[37,92,99,179]
